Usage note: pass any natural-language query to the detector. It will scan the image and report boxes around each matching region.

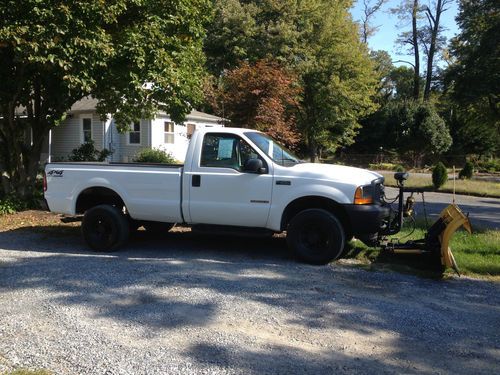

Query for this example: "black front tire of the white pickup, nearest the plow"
[286,208,345,264]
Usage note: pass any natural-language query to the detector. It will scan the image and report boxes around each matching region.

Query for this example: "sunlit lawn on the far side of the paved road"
[381,171,500,198]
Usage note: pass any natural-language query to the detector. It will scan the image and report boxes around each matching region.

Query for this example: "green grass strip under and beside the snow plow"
[347,225,500,280]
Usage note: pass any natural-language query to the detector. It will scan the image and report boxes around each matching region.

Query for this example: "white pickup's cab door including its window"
[186,133,273,228]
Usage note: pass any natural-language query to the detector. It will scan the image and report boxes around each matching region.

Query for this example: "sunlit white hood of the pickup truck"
[289,163,383,186]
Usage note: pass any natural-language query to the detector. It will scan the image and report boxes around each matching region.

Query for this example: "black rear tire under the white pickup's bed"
[82,204,129,251]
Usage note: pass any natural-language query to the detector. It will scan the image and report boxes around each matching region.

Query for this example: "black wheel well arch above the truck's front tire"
[281,196,352,238]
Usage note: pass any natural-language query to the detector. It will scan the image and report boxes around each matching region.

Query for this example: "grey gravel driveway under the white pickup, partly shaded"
[0,228,500,374]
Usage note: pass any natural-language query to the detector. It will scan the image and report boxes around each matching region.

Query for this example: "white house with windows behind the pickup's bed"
[45,97,223,162]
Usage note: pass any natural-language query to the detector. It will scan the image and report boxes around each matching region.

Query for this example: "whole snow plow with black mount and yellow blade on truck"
[379,172,472,276]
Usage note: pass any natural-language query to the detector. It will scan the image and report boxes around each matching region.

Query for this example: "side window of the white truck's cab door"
[200,133,258,171]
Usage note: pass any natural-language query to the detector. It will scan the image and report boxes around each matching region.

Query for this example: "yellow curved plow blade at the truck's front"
[438,204,472,275]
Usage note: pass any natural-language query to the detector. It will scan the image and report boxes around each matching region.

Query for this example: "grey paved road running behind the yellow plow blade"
[386,187,500,229]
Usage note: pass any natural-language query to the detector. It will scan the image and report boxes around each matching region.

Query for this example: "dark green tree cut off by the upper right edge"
[444,0,500,153]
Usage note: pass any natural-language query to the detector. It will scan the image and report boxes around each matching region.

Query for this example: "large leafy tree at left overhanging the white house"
[0,0,210,197]
